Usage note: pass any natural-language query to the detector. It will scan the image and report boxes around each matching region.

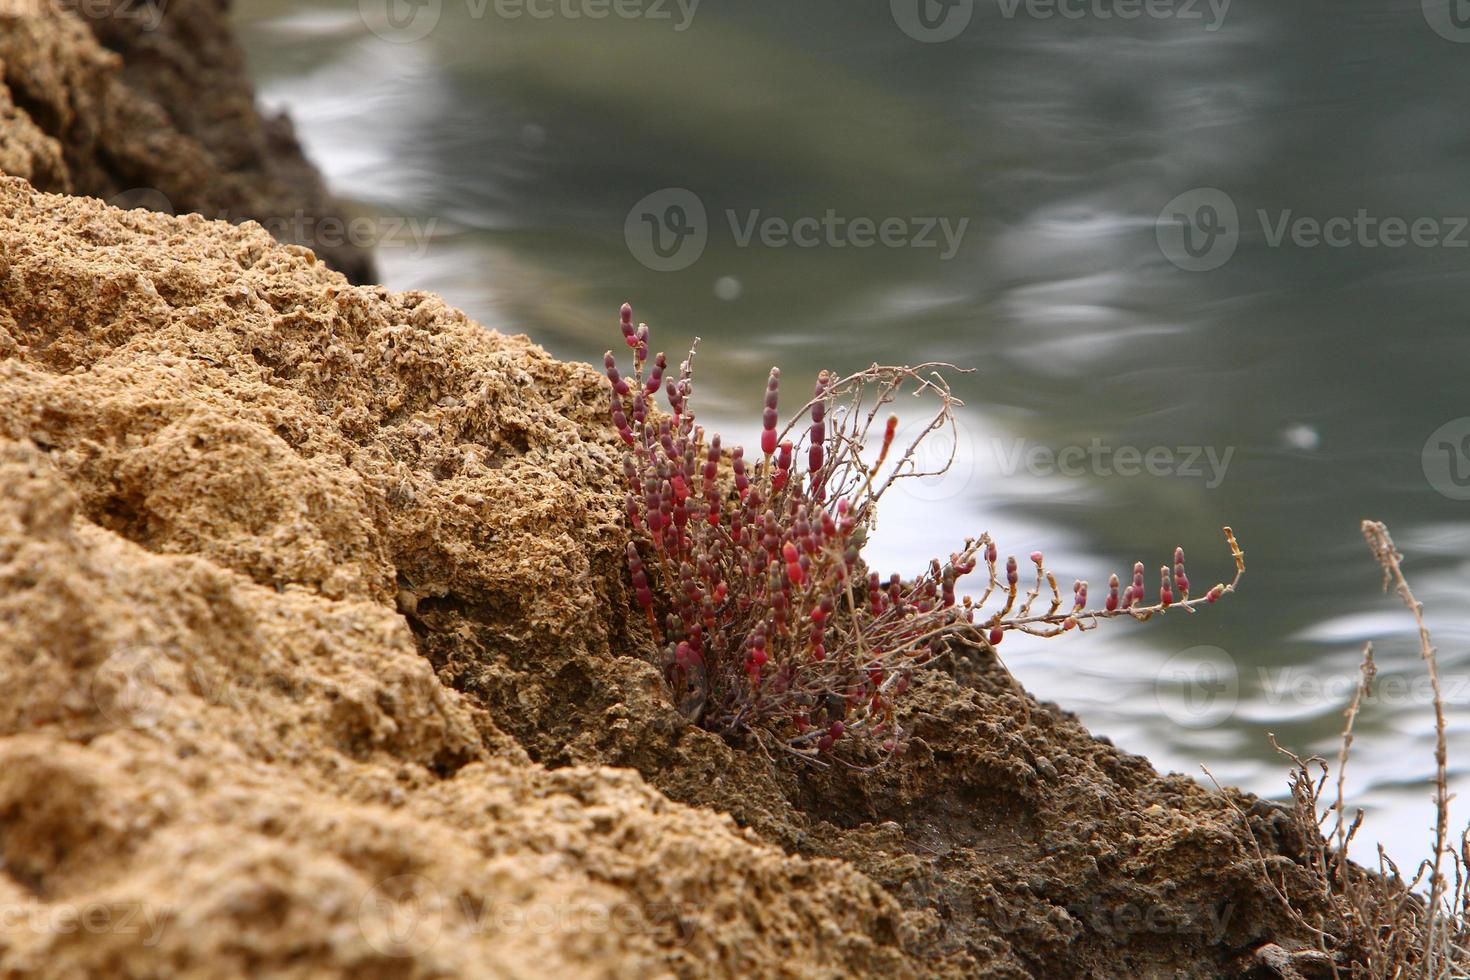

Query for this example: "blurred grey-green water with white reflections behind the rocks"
[238,0,1470,864]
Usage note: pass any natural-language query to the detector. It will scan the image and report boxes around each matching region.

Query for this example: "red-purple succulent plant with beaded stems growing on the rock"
[604,304,1245,764]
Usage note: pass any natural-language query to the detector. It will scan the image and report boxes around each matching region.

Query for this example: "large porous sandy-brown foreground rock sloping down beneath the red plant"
[0,179,1323,977]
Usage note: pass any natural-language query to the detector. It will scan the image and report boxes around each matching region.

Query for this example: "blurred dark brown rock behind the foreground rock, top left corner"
[0,0,376,282]
